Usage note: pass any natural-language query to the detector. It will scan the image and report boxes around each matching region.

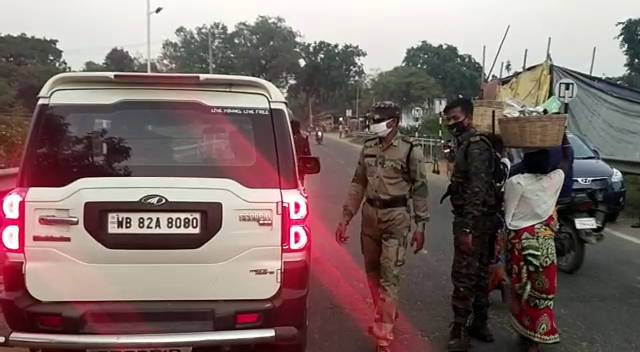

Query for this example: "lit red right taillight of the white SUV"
[282,191,311,253]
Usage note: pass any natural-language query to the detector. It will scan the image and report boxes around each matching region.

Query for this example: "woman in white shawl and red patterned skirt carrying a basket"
[505,150,564,352]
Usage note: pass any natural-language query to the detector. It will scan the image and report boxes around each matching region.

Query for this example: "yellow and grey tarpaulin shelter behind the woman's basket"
[488,62,640,173]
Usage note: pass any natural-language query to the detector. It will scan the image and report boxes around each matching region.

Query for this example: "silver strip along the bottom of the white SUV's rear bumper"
[3,327,298,350]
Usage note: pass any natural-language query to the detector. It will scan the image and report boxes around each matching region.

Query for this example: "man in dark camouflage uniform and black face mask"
[444,99,501,352]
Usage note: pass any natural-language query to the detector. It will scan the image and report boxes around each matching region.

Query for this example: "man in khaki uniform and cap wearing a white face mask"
[336,102,429,351]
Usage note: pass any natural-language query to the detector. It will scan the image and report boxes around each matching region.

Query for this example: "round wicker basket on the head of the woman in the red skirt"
[498,115,567,148]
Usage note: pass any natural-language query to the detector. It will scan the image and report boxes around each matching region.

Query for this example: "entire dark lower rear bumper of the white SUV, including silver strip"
[0,261,309,349]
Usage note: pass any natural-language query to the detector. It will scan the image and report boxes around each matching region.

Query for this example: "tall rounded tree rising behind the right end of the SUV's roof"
[230,16,300,89]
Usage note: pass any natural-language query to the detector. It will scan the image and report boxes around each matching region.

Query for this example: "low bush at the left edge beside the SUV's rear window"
[0,115,29,168]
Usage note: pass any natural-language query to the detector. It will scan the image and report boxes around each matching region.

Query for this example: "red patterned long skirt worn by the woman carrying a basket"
[507,217,560,344]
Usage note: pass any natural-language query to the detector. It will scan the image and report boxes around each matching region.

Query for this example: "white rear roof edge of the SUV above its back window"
[38,72,286,102]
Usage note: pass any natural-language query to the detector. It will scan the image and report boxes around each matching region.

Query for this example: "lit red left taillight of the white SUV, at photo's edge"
[0,188,27,253]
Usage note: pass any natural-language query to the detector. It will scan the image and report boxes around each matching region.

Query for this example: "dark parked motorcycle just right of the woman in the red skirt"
[555,190,608,274]
